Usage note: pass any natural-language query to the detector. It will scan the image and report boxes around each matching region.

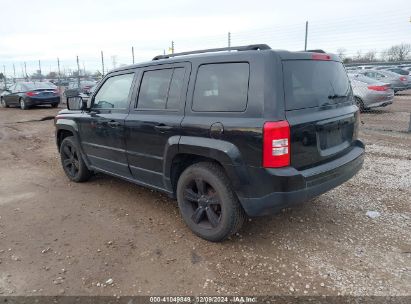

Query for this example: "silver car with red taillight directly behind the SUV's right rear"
[348,74,394,112]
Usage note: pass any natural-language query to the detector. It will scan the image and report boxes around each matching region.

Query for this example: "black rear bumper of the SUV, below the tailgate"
[239,141,364,216]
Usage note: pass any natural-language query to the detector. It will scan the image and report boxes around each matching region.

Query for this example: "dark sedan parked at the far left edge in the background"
[0,82,60,110]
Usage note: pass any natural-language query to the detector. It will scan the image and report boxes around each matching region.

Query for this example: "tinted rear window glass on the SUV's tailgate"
[283,60,351,110]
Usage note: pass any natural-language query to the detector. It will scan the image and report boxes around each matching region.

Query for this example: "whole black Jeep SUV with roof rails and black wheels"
[55,45,364,241]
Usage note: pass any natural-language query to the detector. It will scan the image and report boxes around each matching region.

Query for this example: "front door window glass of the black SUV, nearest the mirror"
[93,74,134,109]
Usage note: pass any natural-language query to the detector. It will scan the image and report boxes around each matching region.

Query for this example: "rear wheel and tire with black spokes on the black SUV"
[177,162,245,242]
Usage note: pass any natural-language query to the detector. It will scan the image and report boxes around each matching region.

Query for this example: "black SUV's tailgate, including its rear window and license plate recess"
[283,60,358,169]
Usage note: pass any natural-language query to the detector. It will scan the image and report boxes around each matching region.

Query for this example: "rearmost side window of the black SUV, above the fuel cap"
[192,63,250,112]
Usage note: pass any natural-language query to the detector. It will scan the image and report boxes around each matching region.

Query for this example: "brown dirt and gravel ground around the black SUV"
[0,95,411,296]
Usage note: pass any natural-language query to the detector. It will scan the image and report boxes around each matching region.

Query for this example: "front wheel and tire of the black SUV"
[60,136,92,183]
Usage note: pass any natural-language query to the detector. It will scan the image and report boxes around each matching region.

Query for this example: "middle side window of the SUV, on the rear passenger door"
[137,68,185,110]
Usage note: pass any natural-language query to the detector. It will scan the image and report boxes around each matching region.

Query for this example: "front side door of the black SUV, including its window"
[79,72,134,178]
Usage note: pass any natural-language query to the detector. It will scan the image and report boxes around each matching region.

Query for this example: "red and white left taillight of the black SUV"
[263,120,290,168]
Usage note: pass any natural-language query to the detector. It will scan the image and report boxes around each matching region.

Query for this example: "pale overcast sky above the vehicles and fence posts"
[0,0,411,77]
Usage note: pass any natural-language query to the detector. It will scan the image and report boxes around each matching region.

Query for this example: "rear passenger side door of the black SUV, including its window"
[125,63,191,188]
